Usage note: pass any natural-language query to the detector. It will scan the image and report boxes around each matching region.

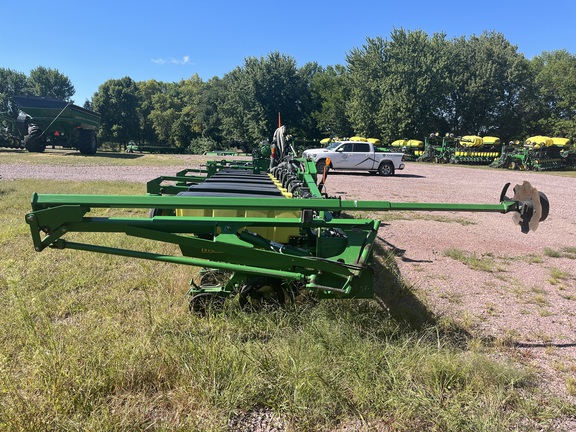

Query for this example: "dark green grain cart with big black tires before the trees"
[0,96,100,155]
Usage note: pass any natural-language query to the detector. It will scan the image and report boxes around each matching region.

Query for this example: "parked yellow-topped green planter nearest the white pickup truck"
[417,134,501,165]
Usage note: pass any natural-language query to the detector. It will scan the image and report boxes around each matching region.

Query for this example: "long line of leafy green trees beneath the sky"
[0,29,576,152]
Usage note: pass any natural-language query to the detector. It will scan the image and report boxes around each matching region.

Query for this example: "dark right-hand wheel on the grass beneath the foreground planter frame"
[239,276,286,310]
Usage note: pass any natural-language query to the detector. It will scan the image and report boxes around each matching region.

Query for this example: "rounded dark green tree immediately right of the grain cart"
[93,77,140,146]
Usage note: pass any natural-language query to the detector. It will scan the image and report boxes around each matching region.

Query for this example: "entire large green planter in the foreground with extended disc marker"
[25,126,549,312]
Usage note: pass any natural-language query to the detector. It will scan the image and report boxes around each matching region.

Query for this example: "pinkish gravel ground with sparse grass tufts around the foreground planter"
[0,156,576,412]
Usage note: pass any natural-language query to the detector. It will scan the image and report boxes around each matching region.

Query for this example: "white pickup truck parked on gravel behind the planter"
[302,141,405,176]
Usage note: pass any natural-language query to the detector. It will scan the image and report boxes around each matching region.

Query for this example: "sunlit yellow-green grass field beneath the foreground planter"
[0,174,573,431]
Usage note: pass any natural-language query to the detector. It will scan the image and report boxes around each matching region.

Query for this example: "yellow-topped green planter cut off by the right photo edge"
[490,135,576,171]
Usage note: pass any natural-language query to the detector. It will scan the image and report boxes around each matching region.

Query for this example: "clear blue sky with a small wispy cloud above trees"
[0,0,576,105]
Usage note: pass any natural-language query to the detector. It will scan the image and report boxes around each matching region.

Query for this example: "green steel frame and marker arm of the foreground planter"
[26,154,548,305]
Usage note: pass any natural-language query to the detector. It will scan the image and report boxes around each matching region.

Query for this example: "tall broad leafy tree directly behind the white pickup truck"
[346,29,447,142]
